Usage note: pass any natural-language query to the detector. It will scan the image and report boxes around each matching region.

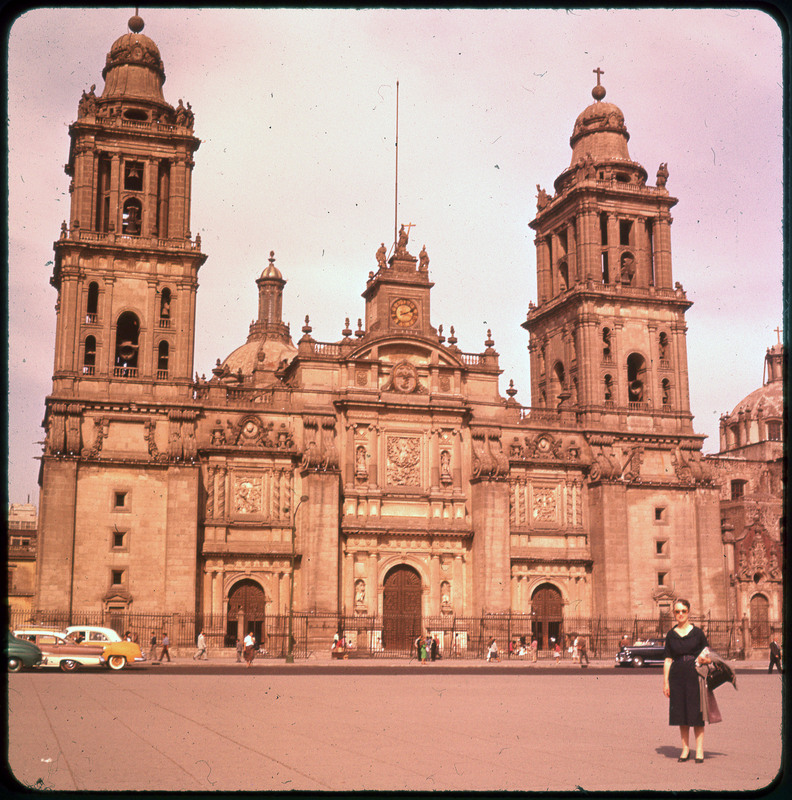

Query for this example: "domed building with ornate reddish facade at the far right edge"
[708,342,785,650]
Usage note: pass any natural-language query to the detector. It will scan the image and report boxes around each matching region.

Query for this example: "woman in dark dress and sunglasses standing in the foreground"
[663,600,710,764]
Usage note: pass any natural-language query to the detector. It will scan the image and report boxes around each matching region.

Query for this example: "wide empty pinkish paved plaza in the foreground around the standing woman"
[8,662,782,792]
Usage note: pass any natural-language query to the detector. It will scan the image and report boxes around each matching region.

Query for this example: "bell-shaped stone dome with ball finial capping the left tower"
[101,17,165,103]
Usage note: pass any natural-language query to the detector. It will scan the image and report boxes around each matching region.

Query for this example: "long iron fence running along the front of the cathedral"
[8,608,782,661]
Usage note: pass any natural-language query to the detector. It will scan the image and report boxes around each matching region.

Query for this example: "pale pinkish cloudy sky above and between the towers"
[7,8,783,503]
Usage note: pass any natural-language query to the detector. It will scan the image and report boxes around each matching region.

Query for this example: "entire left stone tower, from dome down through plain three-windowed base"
[36,15,206,616]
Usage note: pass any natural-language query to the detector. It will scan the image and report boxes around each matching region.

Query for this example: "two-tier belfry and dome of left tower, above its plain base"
[51,16,206,399]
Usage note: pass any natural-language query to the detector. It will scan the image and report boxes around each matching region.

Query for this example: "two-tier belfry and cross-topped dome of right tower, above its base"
[523,70,692,434]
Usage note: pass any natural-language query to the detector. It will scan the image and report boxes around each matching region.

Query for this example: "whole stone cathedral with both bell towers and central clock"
[36,12,729,645]
